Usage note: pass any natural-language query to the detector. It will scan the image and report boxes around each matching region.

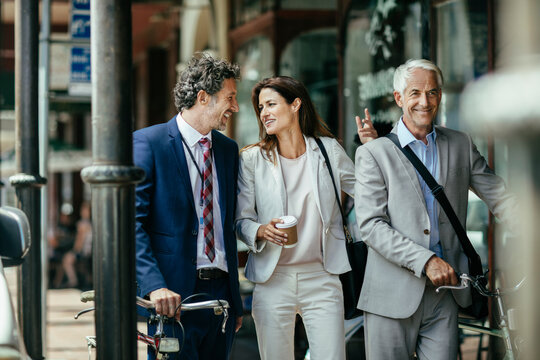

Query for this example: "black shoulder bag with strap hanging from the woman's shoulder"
[315,138,368,320]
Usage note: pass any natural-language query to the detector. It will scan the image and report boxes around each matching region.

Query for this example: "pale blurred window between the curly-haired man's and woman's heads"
[234,36,274,147]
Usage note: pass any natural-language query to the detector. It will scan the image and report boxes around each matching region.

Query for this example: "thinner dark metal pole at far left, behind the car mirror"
[10,0,45,359]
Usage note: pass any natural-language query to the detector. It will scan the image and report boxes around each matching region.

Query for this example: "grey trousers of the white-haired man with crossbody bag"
[364,286,458,360]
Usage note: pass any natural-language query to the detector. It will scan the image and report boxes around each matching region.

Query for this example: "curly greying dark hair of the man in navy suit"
[174,53,240,112]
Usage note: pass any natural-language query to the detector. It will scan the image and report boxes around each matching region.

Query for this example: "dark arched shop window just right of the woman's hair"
[279,28,338,134]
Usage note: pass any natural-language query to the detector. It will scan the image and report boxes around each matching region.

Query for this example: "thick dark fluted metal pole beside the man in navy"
[81,0,144,360]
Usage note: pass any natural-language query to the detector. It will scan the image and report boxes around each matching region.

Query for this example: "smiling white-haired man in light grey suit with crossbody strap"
[355,60,513,360]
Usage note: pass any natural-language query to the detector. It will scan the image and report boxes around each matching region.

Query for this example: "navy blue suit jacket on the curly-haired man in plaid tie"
[133,116,242,316]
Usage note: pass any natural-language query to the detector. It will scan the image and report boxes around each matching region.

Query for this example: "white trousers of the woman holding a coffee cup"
[252,263,345,360]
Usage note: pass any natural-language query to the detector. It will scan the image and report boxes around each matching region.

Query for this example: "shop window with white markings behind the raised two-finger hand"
[342,1,422,157]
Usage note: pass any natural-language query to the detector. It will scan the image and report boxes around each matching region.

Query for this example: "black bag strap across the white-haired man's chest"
[386,133,479,260]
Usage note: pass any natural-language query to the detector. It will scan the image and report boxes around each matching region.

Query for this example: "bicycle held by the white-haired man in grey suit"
[435,274,525,360]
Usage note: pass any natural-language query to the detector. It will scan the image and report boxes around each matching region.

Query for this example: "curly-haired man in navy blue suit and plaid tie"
[133,54,242,359]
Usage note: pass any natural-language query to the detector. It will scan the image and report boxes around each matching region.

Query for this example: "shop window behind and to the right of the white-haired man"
[433,0,489,267]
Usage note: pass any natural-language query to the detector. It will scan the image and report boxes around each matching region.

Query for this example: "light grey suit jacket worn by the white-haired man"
[355,126,514,318]
